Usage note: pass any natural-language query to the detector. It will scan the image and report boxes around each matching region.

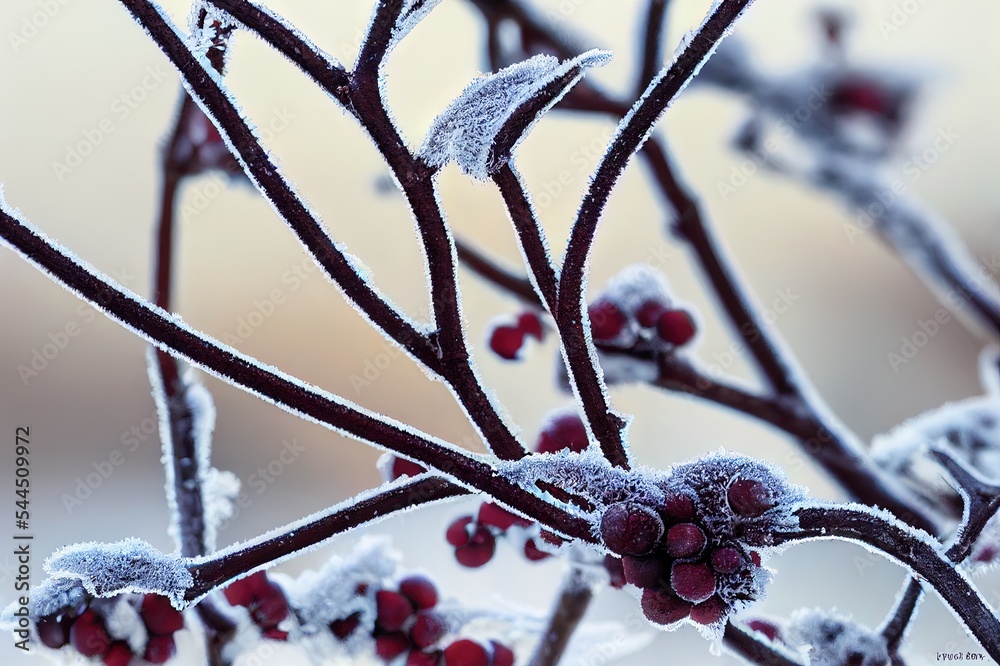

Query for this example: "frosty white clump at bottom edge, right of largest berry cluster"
[782,608,889,666]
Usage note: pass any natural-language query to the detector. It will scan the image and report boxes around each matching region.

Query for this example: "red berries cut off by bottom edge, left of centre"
[330,576,514,666]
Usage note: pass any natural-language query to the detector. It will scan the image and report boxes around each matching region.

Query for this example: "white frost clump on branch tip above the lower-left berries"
[45,539,193,610]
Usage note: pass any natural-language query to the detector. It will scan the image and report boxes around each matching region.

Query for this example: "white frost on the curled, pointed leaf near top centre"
[419,50,611,180]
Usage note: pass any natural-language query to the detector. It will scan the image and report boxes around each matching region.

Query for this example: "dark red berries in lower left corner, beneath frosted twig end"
[35,594,184,666]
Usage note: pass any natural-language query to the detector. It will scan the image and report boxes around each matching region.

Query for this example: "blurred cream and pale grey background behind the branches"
[0,0,1000,666]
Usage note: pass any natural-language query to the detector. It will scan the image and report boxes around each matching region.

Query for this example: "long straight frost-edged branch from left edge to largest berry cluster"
[0,207,593,541]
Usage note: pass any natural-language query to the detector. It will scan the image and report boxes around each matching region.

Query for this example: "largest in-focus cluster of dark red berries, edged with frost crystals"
[600,478,774,625]
